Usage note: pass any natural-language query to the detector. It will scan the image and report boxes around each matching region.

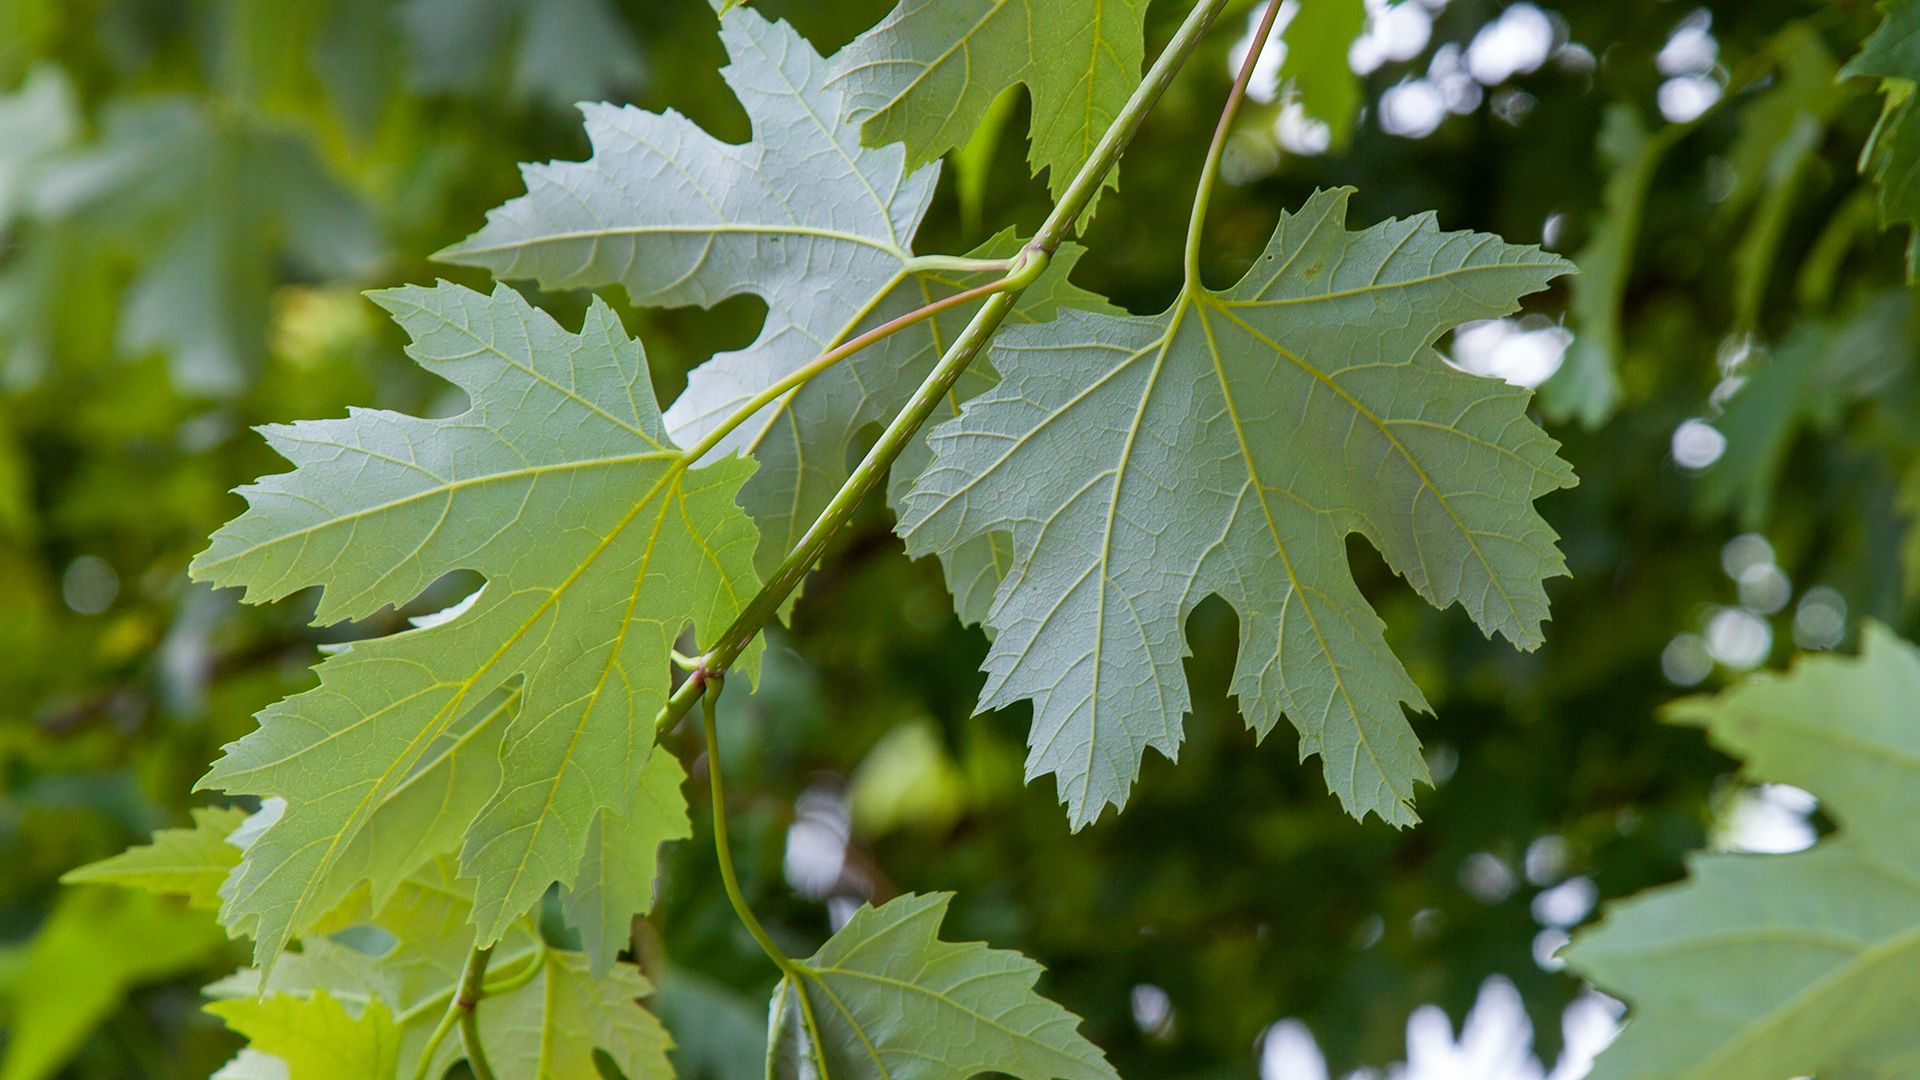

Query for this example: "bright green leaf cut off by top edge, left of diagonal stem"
[833,0,1146,205]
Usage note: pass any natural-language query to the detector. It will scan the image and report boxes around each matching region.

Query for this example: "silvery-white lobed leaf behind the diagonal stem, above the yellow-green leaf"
[442,10,1106,614]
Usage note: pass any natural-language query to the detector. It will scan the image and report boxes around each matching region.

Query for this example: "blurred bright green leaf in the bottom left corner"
[0,888,227,1080]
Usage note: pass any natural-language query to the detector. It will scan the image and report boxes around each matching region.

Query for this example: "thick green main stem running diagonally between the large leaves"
[655,0,1227,730]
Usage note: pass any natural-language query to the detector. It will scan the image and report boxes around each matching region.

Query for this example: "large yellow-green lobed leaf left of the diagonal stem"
[192,284,756,963]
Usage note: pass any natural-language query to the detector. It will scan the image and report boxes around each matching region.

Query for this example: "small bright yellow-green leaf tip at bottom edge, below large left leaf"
[207,990,399,1080]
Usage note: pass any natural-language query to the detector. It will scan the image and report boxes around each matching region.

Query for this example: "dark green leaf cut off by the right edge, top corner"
[1839,0,1920,281]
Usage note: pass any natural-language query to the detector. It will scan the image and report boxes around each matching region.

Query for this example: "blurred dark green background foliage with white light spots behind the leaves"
[0,0,1920,1080]
